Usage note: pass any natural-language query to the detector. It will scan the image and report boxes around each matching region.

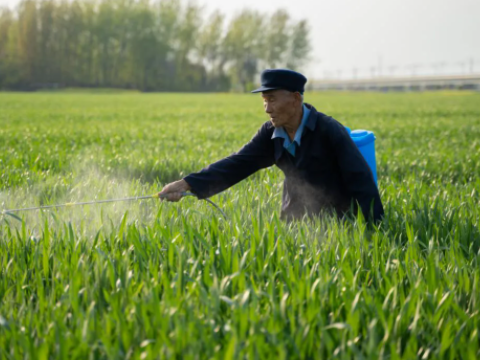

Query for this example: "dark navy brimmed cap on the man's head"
[252,69,307,94]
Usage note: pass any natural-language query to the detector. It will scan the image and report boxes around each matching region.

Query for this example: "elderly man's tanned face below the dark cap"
[262,90,299,128]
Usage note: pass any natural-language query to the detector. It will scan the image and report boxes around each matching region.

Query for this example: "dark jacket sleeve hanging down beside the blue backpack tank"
[328,119,384,222]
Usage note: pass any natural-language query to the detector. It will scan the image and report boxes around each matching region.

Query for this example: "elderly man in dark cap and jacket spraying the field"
[159,69,383,221]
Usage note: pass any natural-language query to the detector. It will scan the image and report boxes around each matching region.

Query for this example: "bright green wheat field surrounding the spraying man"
[0,90,480,360]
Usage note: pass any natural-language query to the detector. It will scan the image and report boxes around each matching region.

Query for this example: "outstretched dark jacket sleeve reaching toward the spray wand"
[184,122,274,199]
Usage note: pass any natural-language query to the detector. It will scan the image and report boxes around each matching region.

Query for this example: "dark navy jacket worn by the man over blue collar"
[184,104,383,221]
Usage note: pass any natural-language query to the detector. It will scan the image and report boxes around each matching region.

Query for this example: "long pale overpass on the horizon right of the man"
[308,74,480,92]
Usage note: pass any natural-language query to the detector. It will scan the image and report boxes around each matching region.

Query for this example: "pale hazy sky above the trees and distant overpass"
[0,0,480,78]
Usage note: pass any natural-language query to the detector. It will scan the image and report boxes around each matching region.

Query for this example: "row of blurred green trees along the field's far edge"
[0,0,311,91]
